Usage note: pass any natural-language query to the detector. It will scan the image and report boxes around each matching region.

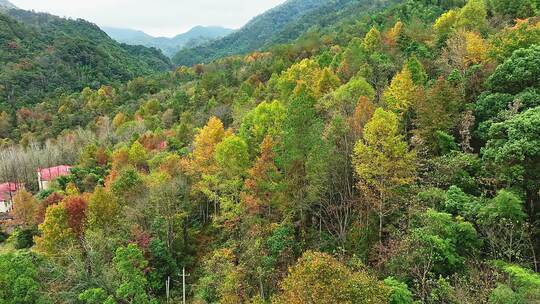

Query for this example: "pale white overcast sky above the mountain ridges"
[10,0,285,37]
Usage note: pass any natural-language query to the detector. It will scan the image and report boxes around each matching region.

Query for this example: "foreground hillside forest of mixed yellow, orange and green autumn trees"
[0,0,540,304]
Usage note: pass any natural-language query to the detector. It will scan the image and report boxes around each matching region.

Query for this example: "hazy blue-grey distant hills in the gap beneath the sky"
[102,26,233,57]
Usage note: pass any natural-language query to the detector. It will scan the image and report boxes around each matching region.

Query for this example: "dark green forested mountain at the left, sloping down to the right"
[0,9,170,110]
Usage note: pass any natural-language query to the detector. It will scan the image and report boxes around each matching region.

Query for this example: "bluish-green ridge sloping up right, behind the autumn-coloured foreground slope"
[172,0,399,66]
